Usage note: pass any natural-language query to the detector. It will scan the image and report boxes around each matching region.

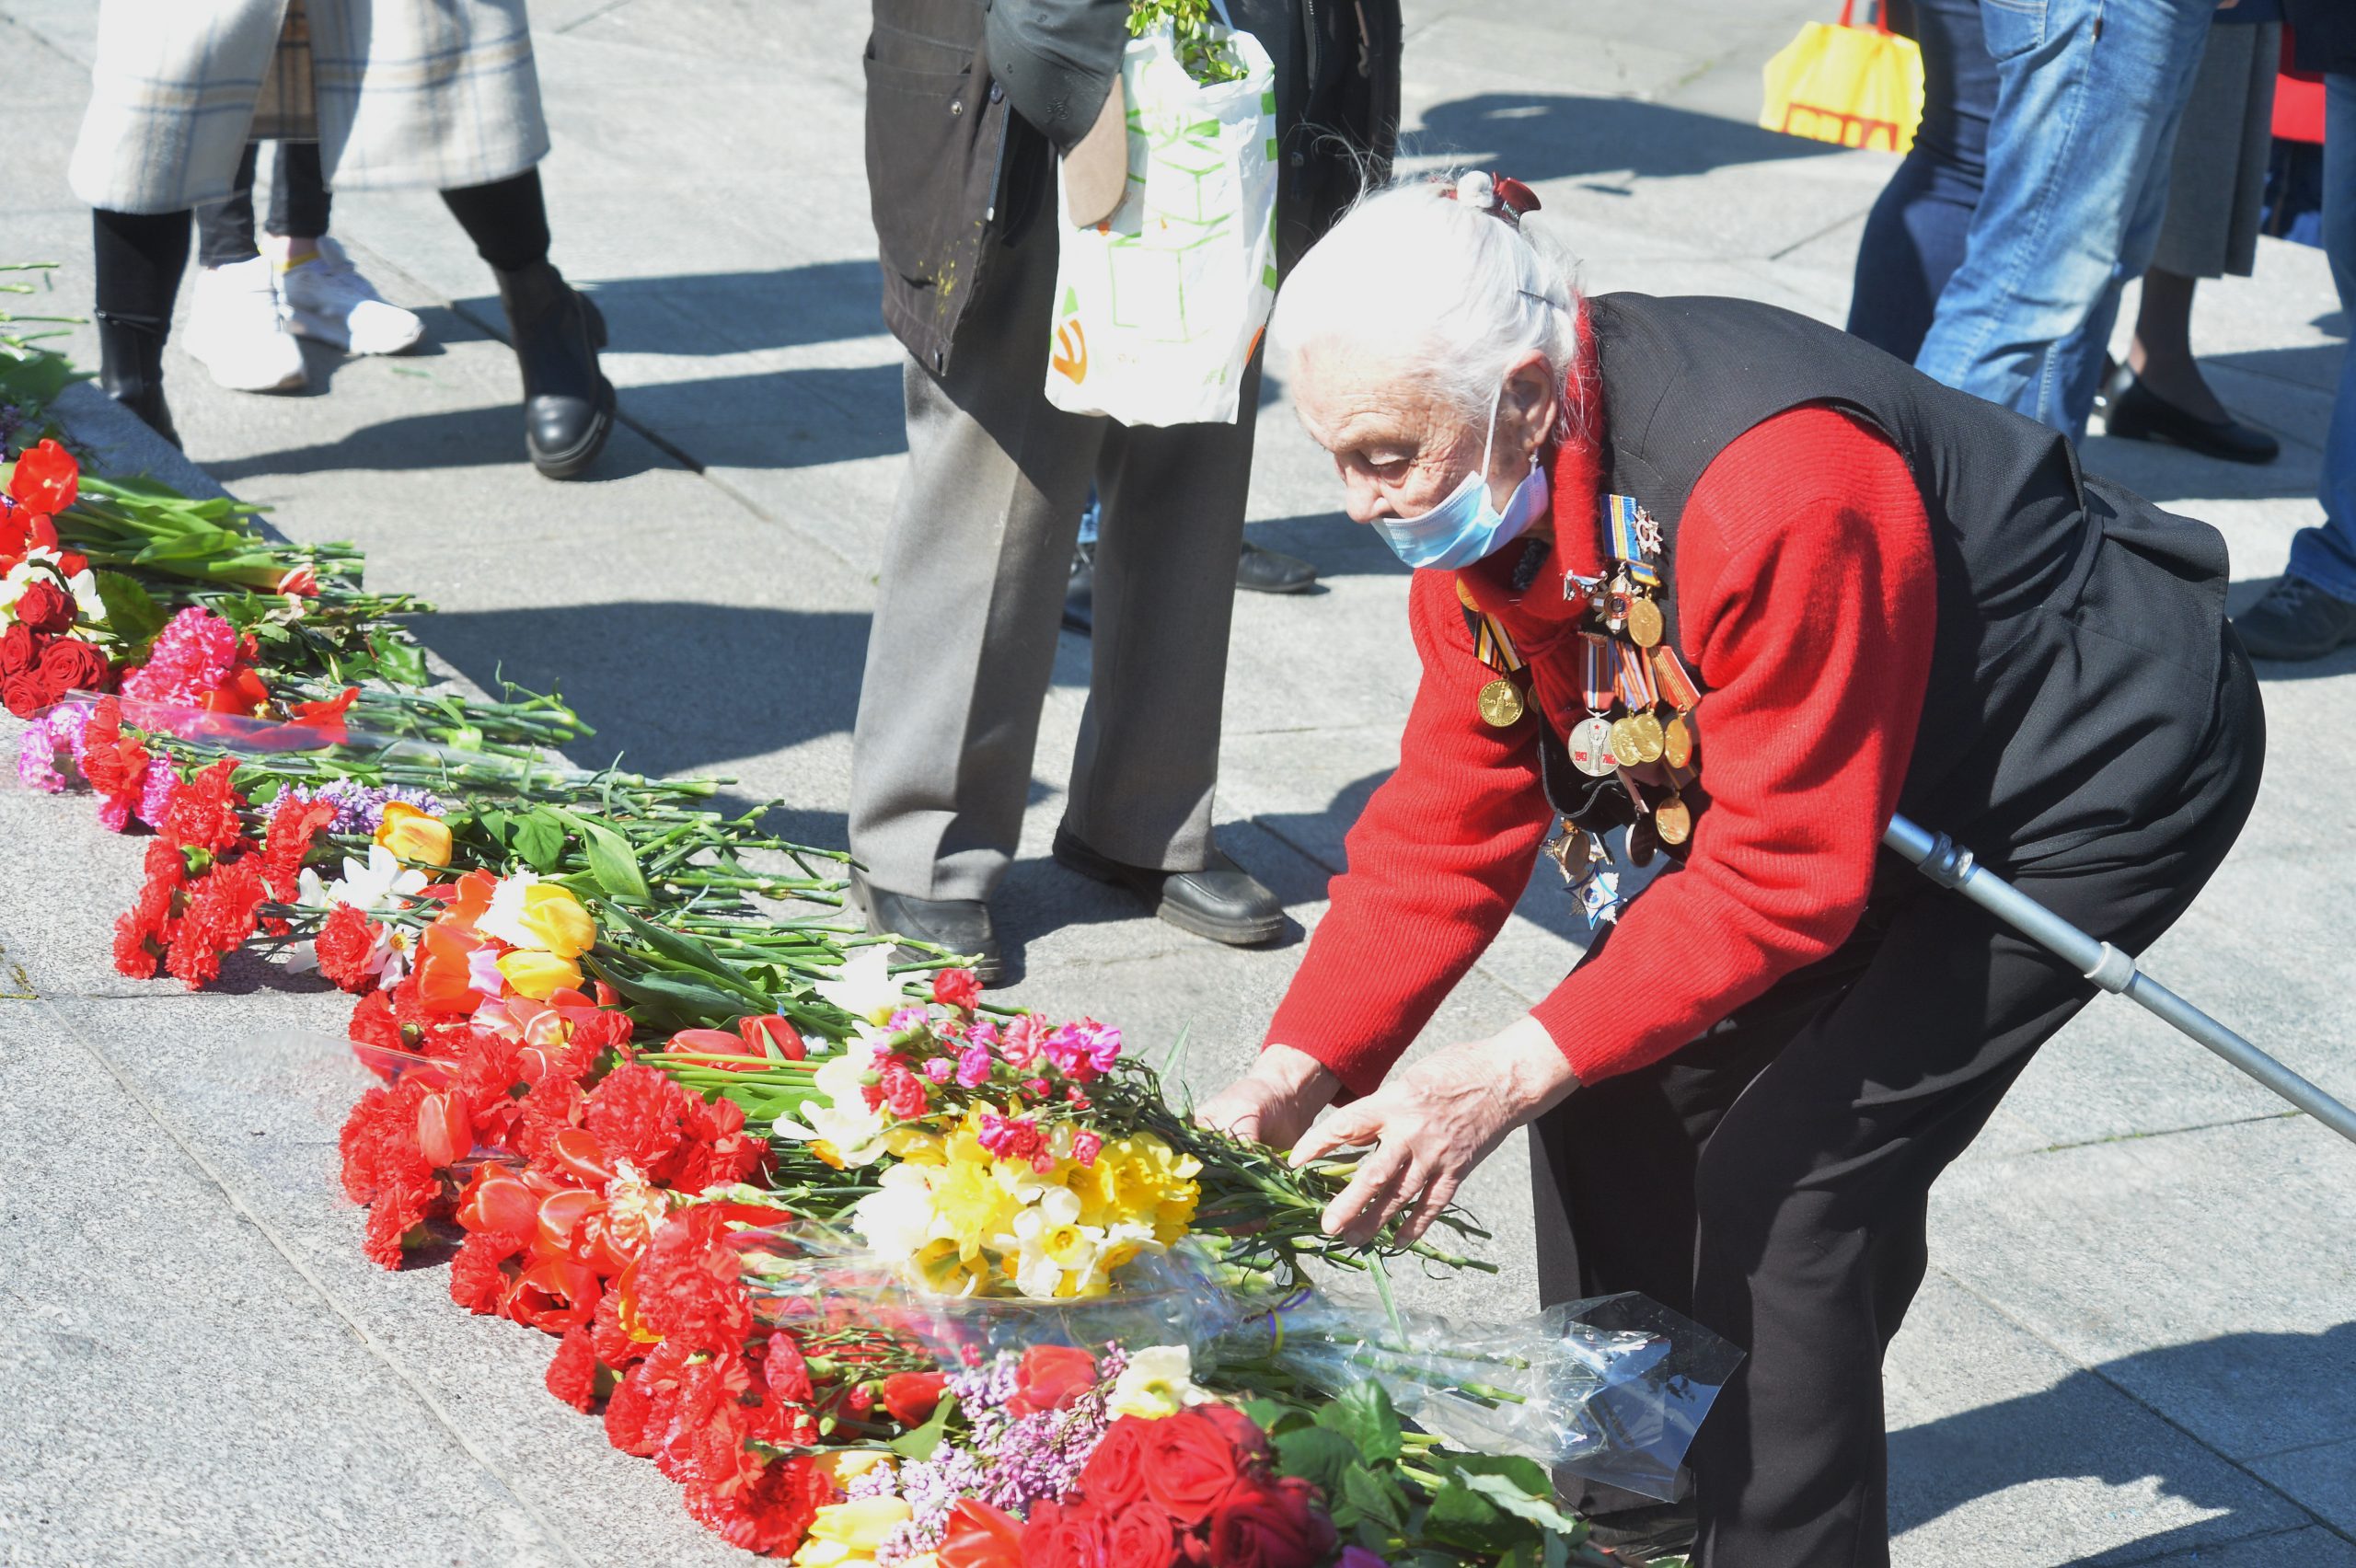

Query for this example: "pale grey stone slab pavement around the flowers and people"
[0,0,2356,1568]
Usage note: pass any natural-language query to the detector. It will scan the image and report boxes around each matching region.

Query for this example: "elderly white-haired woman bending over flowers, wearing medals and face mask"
[1207,174,2264,1568]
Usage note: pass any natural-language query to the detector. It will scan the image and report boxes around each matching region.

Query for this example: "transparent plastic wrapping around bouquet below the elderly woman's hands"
[735,1224,1741,1500]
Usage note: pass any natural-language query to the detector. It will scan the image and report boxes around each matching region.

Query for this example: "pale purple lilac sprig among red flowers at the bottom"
[867,1346,1128,1568]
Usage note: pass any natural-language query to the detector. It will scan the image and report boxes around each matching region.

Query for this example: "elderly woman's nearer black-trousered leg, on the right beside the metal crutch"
[1694,645,2264,1568]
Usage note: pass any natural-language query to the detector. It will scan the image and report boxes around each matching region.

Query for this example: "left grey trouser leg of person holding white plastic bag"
[850,202,1103,935]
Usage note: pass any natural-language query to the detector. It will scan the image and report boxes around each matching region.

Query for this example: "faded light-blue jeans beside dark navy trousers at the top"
[1915,0,2217,438]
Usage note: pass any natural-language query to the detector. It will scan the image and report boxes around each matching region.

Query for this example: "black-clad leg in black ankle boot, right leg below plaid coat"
[443,169,615,478]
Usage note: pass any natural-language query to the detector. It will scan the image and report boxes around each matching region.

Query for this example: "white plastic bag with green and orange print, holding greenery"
[1046,7,1277,424]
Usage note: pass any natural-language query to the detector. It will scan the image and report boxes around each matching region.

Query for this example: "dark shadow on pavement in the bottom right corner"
[1889,1323,2356,1568]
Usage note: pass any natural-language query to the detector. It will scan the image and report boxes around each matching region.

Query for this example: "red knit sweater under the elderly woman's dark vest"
[1267,408,1936,1095]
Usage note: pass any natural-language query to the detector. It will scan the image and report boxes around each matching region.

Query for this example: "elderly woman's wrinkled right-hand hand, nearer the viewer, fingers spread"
[1293,1017,1578,1245]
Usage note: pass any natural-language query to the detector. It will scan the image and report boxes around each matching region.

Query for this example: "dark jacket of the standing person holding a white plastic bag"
[867,0,1400,375]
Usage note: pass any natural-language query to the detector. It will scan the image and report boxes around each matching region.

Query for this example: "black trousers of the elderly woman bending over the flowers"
[1531,631,2264,1568]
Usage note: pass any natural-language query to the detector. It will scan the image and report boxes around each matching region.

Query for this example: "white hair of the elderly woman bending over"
[1267,174,1583,438]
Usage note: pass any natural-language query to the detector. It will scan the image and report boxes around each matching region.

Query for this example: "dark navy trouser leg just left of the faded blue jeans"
[1850,0,1995,365]
